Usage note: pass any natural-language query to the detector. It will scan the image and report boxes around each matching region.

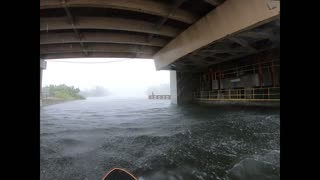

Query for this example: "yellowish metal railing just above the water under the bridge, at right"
[194,87,280,101]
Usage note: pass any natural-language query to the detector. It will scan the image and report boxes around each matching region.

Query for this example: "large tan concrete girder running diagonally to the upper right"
[153,0,280,70]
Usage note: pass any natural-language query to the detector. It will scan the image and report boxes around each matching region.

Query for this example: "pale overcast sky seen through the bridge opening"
[42,58,170,96]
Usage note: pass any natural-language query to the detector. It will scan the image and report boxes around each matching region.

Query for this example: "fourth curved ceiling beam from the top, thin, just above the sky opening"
[40,43,160,55]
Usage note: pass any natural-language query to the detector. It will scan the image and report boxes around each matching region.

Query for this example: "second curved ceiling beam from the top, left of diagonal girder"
[40,17,180,37]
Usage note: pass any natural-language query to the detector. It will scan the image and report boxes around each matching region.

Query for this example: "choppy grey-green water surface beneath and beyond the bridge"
[40,98,280,180]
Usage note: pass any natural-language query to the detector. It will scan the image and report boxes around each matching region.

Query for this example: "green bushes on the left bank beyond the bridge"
[42,84,85,100]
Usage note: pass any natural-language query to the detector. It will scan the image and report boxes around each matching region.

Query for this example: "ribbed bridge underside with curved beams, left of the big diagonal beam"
[40,0,224,59]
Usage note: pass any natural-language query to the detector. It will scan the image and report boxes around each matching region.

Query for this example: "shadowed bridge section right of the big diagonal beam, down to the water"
[168,19,280,105]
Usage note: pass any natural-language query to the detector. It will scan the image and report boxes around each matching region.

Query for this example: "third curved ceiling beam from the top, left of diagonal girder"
[40,32,169,47]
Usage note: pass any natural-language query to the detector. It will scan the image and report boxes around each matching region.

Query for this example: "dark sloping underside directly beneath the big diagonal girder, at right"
[162,19,280,72]
